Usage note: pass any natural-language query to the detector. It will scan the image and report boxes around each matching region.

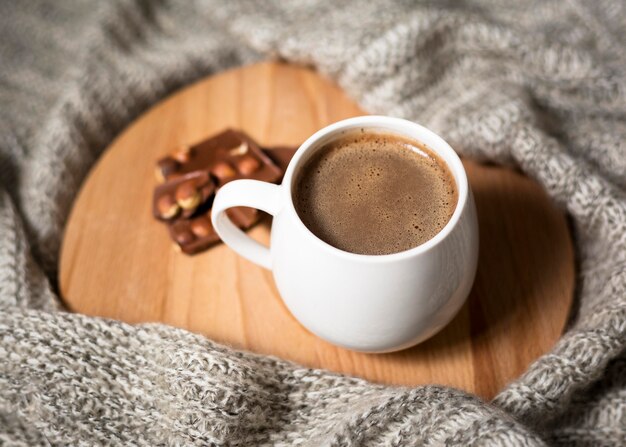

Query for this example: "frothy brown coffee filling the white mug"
[293,131,457,255]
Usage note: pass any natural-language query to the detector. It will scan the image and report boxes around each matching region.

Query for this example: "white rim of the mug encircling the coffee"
[281,115,470,262]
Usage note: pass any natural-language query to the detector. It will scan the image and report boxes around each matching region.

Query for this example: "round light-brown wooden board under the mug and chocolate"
[60,63,574,398]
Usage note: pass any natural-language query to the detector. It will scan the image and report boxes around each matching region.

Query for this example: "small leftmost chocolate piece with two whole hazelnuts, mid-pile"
[152,171,215,220]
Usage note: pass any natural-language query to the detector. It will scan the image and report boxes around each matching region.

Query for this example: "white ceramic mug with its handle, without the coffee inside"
[212,116,478,352]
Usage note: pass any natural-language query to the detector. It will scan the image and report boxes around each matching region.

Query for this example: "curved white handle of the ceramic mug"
[211,180,281,270]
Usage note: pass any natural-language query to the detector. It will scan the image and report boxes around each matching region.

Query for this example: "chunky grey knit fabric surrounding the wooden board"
[0,0,626,446]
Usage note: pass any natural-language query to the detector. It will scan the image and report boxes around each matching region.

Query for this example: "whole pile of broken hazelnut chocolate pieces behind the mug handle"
[152,129,296,255]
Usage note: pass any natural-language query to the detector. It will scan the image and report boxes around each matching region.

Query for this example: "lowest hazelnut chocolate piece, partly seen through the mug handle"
[169,207,259,255]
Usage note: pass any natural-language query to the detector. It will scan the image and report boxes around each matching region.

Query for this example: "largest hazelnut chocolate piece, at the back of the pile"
[157,129,283,186]
